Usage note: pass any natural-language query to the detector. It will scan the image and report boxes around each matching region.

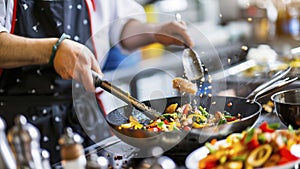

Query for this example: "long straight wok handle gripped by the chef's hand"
[92,70,160,119]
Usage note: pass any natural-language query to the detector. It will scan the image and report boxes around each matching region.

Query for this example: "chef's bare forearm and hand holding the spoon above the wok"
[121,19,193,50]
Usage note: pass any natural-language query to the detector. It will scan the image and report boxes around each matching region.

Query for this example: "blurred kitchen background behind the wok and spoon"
[103,0,300,112]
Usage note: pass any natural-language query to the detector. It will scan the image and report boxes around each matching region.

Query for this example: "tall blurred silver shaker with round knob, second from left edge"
[7,115,43,169]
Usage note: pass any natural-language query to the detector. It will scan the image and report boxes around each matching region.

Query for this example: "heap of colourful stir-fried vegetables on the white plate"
[198,122,300,169]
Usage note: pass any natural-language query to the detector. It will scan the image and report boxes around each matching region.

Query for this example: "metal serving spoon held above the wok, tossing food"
[175,13,204,81]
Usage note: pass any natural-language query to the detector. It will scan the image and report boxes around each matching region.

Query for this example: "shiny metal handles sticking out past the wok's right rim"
[246,66,298,102]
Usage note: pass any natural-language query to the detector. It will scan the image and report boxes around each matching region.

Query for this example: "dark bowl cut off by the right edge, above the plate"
[271,88,300,129]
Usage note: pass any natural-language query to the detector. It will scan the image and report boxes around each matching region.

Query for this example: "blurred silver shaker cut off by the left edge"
[0,117,17,169]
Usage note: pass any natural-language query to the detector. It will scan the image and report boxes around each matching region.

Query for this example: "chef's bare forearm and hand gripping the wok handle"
[0,32,102,91]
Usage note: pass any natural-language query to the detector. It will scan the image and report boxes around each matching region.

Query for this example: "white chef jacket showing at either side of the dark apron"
[0,0,145,67]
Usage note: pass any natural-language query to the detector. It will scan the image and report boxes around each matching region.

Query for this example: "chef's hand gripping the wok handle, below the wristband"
[53,39,103,92]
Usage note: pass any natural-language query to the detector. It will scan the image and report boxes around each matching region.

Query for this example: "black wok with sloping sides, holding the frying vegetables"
[106,96,261,156]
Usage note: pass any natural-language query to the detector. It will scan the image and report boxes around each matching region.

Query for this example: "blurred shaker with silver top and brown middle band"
[59,127,86,169]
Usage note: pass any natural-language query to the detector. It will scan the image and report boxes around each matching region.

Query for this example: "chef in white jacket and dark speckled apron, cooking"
[0,0,192,163]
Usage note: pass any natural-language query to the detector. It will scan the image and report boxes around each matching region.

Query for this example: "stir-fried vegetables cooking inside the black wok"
[120,103,240,131]
